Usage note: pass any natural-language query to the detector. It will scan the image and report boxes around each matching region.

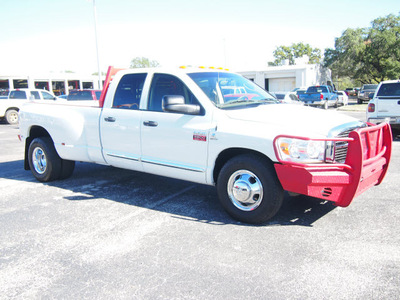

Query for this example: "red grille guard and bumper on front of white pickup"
[274,123,392,207]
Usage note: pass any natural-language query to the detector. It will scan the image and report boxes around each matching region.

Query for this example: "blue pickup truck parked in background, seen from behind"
[299,85,338,109]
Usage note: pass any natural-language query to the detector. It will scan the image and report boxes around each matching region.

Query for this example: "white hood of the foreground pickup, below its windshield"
[224,104,362,137]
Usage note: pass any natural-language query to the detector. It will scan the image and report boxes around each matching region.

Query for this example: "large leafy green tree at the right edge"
[323,15,400,83]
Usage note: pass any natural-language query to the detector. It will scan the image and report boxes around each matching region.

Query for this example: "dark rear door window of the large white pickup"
[112,74,147,109]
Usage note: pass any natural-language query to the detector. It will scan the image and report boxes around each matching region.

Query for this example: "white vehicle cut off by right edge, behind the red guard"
[367,80,400,135]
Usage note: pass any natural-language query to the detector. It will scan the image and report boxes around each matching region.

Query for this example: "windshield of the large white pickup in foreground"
[188,72,279,108]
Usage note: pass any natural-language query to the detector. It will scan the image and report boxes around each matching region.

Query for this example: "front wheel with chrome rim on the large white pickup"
[217,154,283,224]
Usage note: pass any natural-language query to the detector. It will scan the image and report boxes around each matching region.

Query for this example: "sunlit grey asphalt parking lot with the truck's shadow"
[0,111,400,299]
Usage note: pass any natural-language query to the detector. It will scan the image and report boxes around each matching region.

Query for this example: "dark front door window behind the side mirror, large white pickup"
[148,74,200,111]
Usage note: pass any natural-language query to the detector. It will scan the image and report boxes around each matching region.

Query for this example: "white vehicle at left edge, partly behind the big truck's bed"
[0,89,57,125]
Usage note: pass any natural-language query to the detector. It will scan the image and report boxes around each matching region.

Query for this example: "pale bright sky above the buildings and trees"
[0,0,400,75]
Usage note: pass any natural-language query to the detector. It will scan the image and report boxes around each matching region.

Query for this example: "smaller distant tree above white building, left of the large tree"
[269,43,321,66]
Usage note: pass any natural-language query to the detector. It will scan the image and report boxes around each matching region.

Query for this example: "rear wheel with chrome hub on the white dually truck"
[28,137,62,182]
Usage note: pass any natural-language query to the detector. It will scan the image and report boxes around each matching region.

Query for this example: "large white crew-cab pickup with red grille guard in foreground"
[20,67,392,223]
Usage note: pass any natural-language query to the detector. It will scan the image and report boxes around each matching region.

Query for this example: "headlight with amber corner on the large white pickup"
[275,137,326,163]
